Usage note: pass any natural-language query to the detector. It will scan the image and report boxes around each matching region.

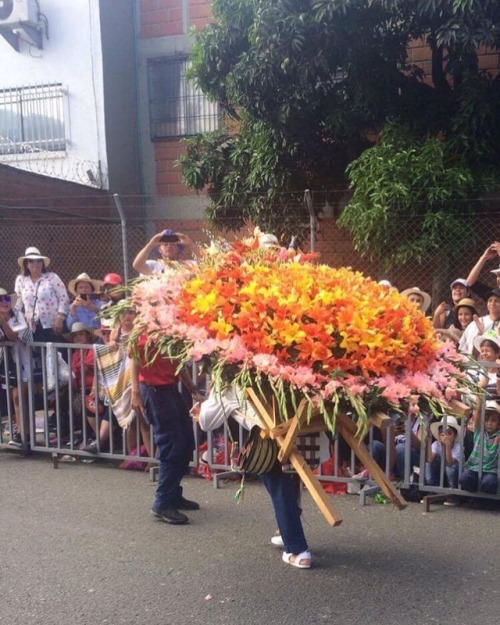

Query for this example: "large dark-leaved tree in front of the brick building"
[181,0,500,251]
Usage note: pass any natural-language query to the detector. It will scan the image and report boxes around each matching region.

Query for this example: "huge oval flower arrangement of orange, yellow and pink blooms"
[132,234,476,434]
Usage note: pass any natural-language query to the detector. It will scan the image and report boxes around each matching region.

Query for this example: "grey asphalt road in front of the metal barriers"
[0,452,500,625]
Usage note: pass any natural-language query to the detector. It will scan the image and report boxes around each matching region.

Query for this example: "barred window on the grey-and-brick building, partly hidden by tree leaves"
[148,56,220,140]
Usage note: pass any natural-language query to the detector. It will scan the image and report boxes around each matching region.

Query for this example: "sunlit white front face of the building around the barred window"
[0,0,107,186]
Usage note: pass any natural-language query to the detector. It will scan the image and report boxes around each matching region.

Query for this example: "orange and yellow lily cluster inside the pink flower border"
[178,255,437,377]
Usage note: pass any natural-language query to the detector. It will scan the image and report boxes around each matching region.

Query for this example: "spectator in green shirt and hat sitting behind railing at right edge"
[459,400,500,495]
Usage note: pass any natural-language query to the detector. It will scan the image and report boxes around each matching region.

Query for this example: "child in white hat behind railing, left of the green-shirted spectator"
[425,415,461,490]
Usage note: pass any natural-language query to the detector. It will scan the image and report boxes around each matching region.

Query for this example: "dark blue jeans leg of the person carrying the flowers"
[261,461,308,555]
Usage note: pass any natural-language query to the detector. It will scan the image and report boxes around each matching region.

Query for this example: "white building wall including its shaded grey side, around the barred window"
[0,0,141,201]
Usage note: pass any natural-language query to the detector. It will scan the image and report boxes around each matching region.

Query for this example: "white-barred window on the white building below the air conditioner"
[0,84,66,154]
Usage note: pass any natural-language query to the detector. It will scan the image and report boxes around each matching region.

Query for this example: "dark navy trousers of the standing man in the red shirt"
[141,384,194,510]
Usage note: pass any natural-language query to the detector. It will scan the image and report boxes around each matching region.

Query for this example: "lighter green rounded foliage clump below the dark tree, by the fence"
[339,124,495,267]
